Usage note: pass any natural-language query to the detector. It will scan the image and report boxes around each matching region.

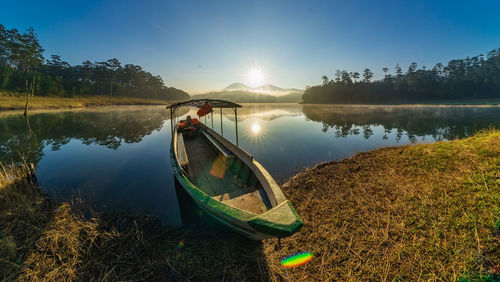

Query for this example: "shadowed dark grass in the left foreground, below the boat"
[0,163,268,281]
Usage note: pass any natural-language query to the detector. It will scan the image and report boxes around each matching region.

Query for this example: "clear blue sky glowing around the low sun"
[0,0,500,94]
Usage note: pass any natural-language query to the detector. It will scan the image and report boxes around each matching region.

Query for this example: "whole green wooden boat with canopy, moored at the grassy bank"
[167,99,302,240]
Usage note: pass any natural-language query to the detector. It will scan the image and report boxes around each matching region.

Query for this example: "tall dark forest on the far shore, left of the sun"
[0,24,189,100]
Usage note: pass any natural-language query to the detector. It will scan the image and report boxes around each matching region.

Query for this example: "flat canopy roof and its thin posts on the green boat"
[167,99,241,146]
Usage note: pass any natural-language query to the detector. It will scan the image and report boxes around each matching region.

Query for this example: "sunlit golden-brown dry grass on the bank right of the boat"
[264,130,500,281]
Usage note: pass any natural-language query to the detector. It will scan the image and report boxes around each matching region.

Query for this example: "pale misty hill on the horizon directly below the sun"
[192,83,304,103]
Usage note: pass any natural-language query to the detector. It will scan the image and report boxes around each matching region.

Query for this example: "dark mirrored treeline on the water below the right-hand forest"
[302,105,500,143]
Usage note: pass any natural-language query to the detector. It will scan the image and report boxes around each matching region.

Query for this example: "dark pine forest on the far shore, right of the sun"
[302,48,500,104]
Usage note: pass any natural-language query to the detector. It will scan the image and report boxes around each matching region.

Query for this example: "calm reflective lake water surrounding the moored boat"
[0,104,500,227]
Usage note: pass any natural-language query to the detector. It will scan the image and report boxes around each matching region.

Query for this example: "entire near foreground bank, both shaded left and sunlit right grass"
[0,130,500,281]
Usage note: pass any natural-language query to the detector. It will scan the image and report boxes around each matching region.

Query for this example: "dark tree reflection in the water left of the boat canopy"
[0,106,187,164]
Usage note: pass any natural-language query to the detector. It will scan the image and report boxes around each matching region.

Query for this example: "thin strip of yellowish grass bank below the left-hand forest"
[0,94,169,111]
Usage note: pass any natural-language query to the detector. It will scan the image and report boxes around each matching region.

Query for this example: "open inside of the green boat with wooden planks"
[176,130,272,214]
